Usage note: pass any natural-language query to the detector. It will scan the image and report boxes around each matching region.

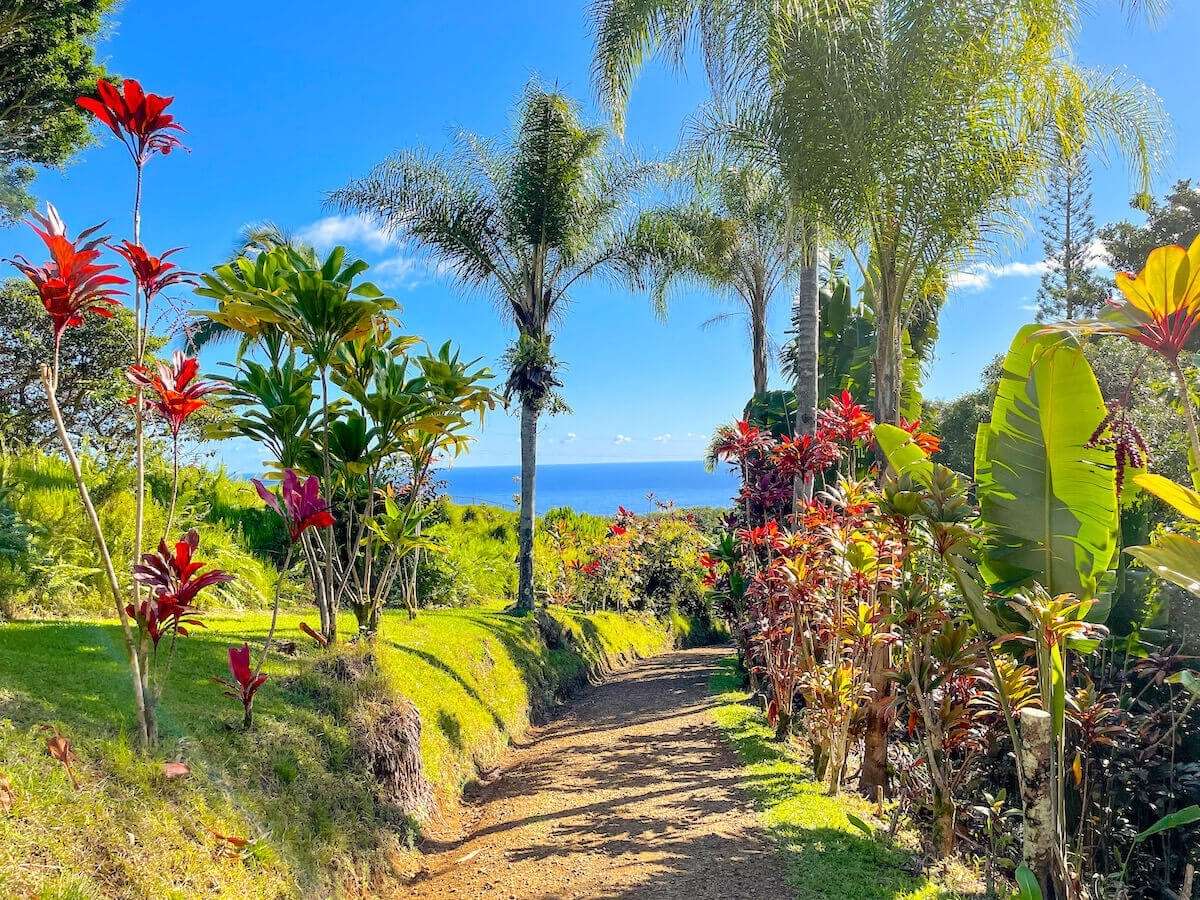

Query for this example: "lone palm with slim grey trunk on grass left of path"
[330,84,652,611]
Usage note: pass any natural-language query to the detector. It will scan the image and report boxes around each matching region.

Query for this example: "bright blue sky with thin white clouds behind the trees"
[0,0,1200,472]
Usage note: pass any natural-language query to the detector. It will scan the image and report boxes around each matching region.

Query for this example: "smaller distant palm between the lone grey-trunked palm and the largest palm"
[638,164,804,396]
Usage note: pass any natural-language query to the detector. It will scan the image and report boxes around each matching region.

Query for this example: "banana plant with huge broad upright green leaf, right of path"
[875,325,1118,896]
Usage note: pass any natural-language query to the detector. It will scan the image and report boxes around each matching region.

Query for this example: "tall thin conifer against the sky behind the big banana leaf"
[1038,155,1111,322]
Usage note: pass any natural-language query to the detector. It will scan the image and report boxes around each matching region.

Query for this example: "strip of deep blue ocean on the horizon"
[439,461,738,516]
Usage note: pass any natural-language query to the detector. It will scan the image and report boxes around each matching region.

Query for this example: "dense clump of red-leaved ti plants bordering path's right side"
[702,392,931,793]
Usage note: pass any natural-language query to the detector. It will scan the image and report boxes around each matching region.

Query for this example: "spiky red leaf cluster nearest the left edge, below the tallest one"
[8,204,128,343]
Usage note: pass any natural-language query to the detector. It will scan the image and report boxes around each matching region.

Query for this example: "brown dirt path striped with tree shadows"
[410,648,791,900]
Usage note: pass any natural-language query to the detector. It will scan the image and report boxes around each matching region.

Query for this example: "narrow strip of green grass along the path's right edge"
[709,659,960,900]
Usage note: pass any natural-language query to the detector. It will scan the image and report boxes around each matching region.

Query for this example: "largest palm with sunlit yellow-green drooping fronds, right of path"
[718,0,1162,432]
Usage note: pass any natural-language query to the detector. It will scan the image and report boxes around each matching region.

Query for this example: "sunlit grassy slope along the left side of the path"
[0,608,670,898]
